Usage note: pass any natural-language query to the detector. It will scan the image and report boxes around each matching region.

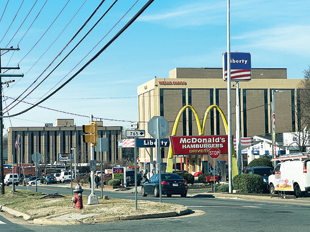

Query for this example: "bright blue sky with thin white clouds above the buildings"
[0,0,310,134]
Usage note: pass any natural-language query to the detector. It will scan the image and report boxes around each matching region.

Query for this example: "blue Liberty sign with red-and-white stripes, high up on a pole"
[223,52,251,81]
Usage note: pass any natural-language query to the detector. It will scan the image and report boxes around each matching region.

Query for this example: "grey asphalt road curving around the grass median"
[0,186,310,232]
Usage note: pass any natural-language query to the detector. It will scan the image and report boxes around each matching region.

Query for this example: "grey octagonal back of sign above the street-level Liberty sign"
[148,116,169,139]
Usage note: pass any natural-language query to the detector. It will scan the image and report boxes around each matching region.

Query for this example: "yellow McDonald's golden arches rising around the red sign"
[166,105,238,176]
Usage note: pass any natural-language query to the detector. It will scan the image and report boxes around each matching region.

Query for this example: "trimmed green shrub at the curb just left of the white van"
[233,174,263,193]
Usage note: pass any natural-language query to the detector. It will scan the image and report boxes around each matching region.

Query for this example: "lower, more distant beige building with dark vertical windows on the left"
[8,119,123,167]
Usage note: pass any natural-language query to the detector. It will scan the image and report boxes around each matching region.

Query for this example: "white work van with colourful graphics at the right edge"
[268,154,310,197]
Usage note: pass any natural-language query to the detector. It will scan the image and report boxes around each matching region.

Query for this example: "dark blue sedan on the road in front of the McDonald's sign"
[141,173,187,197]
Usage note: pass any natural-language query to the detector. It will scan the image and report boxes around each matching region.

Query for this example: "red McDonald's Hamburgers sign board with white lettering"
[170,135,228,155]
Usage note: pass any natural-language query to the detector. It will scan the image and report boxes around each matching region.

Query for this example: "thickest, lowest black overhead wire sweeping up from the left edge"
[0,0,154,118]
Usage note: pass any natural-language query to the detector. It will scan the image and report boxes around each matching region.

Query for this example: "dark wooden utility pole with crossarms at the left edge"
[0,46,24,195]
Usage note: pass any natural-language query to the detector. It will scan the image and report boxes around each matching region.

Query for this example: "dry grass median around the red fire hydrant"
[0,187,186,219]
